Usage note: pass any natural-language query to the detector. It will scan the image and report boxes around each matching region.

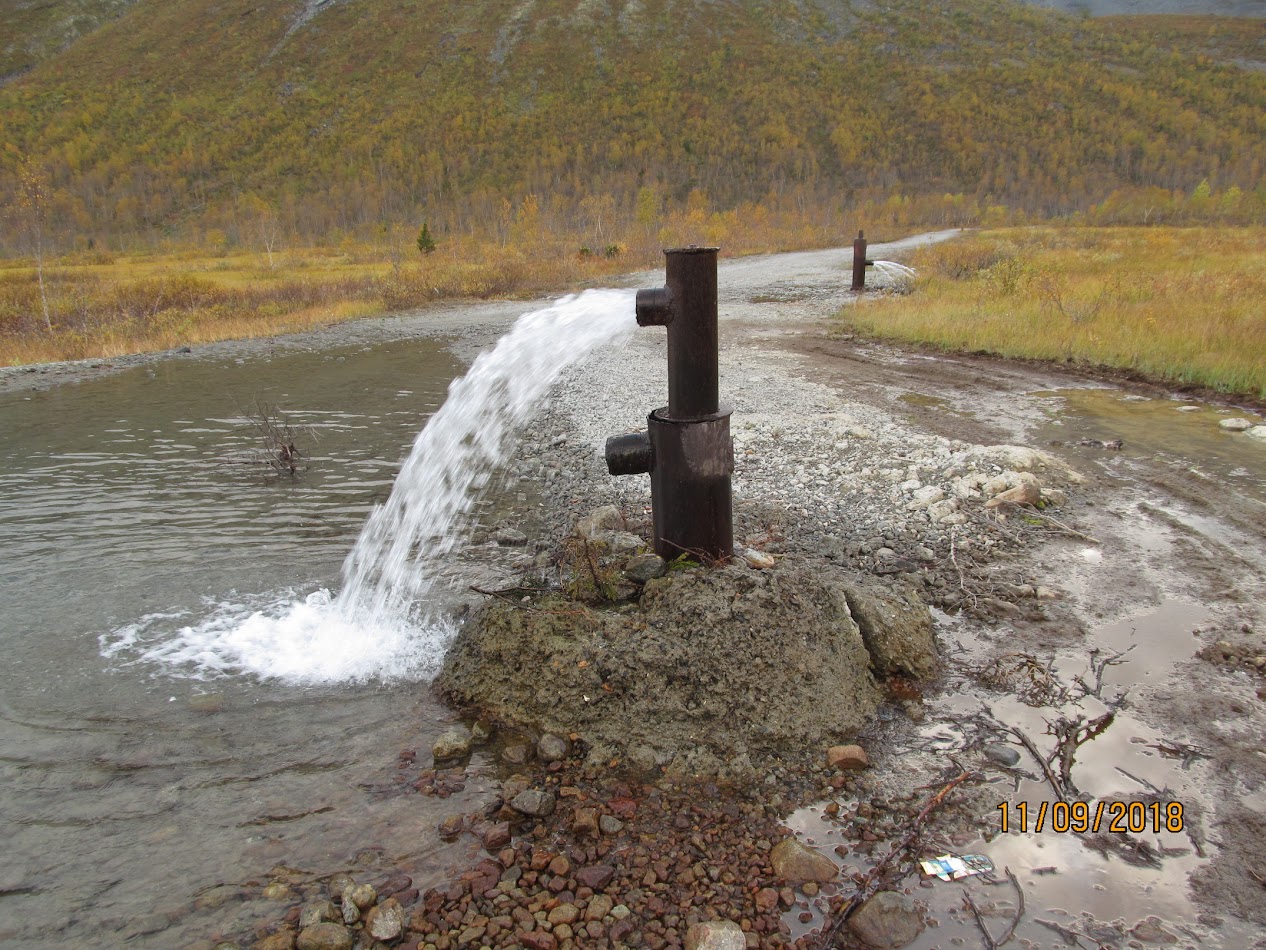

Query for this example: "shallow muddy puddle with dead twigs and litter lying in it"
[784,599,1261,950]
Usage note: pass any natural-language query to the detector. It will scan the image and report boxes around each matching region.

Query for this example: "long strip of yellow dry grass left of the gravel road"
[0,206,839,365]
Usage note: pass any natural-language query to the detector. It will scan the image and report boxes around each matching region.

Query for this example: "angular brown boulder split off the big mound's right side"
[844,583,938,679]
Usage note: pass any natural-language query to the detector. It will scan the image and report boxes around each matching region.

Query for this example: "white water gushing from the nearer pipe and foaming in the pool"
[100,290,636,684]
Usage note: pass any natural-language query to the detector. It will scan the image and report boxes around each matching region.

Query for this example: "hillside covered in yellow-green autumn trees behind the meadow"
[0,0,1266,253]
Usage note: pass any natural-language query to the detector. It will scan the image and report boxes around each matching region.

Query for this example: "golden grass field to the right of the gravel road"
[842,227,1266,398]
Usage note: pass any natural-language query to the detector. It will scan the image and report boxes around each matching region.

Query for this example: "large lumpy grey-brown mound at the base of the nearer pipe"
[436,556,886,776]
